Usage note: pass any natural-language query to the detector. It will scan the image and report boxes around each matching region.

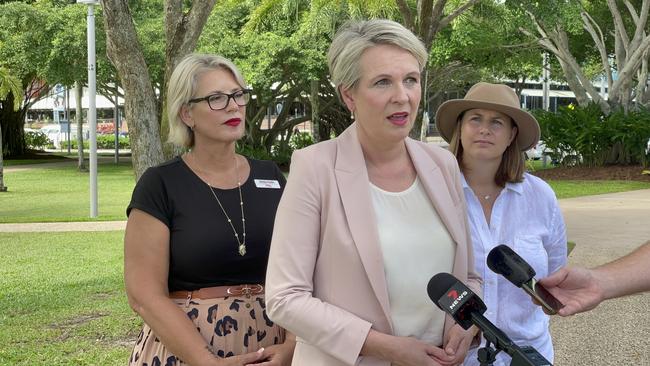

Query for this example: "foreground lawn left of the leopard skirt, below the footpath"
[0,231,141,365]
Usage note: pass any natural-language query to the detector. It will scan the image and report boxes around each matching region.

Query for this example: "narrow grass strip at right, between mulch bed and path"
[547,180,650,199]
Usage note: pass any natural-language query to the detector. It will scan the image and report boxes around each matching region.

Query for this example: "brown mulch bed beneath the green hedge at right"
[531,165,650,182]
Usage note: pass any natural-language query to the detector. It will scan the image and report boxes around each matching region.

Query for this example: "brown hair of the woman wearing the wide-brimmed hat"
[449,112,526,187]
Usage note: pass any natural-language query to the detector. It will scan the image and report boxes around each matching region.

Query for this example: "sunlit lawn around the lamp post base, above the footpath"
[0,163,135,223]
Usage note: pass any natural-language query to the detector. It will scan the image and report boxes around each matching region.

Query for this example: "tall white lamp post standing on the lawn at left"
[77,0,99,218]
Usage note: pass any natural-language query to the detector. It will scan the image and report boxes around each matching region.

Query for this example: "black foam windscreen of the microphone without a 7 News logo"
[487,244,535,287]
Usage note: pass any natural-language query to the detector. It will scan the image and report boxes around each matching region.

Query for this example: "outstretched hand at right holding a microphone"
[539,267,605,316]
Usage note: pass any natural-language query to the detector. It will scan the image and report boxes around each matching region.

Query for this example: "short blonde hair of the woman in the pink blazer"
[327,19,428,97]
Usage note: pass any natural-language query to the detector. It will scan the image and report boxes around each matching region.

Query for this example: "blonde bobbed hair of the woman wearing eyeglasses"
[167,53,246,147]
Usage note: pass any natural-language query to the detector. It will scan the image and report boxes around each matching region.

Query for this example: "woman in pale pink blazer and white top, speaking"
[266,19,480,366]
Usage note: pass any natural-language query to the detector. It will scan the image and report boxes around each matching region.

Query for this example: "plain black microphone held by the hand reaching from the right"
[487,244,564,314]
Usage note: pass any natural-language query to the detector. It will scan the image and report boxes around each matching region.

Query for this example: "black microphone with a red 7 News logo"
[427,272,553,366]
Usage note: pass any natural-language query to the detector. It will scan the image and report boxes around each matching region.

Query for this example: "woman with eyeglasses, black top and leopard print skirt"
[124,54,294,366]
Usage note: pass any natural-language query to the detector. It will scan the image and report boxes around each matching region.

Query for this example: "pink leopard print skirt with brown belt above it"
[129,294,285,366]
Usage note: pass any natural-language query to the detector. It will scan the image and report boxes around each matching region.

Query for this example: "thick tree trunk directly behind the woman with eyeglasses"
[102,0,163,180]
